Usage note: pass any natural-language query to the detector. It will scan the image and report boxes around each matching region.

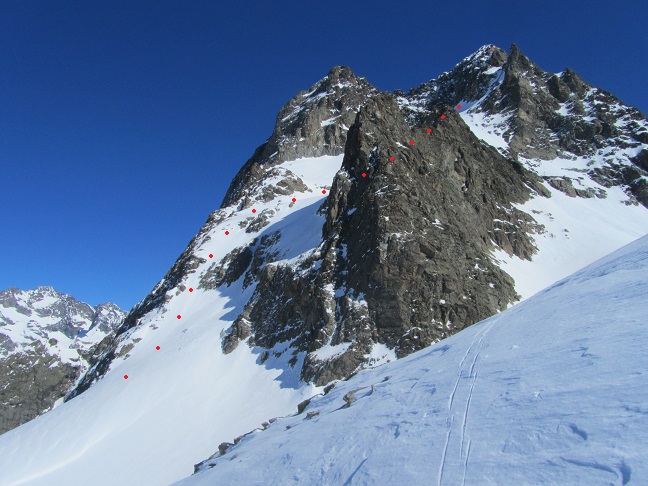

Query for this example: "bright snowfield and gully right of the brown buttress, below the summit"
[458,79,648,298]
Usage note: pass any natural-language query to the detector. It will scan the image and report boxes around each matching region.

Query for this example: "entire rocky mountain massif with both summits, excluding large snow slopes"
[68,46,648,398]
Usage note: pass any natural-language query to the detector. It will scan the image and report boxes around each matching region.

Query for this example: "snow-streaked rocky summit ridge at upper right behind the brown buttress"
[399,45,648,207]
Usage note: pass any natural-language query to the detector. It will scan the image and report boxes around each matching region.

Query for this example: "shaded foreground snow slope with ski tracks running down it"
[177,236,648,486]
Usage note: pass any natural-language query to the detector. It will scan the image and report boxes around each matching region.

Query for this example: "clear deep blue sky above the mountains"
[0,0,648,309]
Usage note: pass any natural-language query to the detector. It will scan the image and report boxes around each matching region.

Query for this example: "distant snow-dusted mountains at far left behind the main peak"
[0,287,125,434]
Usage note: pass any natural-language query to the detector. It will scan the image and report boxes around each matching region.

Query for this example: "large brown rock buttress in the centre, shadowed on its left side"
[224,93,542,384]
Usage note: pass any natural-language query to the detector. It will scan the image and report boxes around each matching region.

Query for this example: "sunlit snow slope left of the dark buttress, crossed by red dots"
[0,156,342,486]
